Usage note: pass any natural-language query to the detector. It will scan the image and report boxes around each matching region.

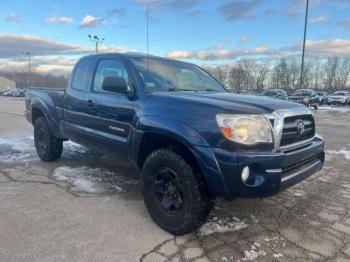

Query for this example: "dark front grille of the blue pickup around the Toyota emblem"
[280,115,315,147]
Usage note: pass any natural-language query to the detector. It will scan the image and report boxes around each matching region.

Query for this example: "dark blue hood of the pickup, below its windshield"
[153,91,302,114]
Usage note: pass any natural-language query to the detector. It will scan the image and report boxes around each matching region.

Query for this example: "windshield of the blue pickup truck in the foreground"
[131,57,225,92]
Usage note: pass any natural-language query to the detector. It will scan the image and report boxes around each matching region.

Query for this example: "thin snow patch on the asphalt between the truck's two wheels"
[52,166,139,194]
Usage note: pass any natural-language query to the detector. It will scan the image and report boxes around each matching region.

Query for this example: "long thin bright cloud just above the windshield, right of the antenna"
[166,45,273,60]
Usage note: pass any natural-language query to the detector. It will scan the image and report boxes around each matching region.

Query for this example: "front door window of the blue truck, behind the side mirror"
[93,60,129,93]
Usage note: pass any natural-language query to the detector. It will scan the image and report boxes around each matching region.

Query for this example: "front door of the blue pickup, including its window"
[82,57,135,155]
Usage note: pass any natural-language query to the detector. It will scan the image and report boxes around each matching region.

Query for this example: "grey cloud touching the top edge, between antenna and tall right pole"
[218,0,261,21]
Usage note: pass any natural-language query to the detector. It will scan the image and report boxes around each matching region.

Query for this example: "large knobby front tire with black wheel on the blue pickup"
[142,148,213,235]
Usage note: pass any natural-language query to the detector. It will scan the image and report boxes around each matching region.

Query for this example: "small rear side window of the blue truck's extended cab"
[72,60,92,91]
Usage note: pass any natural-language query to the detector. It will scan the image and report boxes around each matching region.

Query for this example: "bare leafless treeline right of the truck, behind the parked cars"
[205,56,350,92]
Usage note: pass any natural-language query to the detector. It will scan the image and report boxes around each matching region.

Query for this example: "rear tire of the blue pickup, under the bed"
[34,117,63,162]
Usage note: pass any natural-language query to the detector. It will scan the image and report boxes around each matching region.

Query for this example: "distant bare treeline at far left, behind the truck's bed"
[0,72,68,88]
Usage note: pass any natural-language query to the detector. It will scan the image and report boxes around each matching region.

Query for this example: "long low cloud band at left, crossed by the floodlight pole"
[0,35,126,58]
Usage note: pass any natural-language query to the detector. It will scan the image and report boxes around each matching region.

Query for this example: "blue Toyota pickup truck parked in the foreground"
[25,53,324,235]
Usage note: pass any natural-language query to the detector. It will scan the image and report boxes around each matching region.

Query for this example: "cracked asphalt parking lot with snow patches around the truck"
[0,98,350,262]
